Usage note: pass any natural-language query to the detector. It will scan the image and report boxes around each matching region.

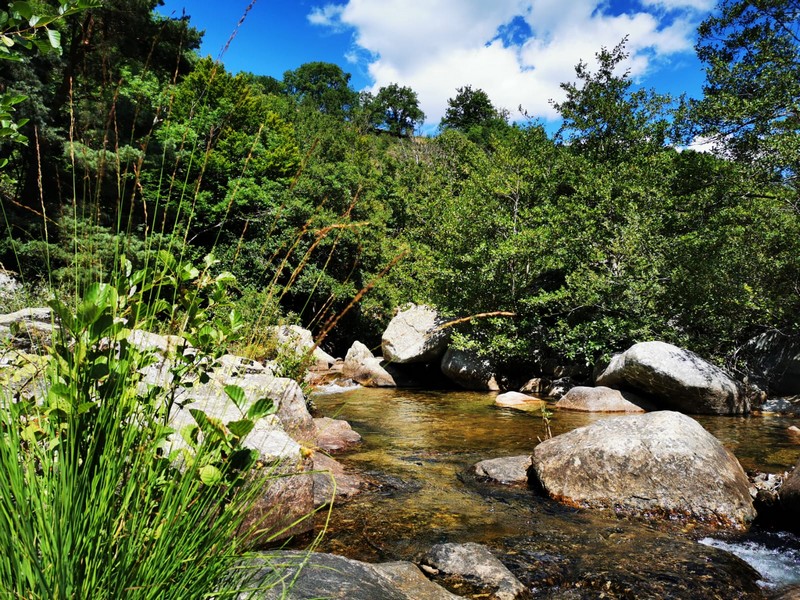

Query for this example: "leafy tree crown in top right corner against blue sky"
[692,0,800,206]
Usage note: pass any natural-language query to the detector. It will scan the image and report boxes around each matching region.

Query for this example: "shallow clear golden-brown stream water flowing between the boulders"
[314,389,800,598]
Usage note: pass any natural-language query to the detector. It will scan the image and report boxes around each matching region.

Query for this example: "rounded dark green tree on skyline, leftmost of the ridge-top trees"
[283,62,358,117]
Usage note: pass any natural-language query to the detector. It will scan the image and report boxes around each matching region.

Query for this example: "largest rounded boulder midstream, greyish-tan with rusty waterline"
[528,411,755,526]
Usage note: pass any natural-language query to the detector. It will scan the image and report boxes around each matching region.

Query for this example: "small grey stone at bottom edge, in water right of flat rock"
[425,542,527,600]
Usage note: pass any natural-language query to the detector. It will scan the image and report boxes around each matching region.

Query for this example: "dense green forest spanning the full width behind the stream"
[0,0,800,382]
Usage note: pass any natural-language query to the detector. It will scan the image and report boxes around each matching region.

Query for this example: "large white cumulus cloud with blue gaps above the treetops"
[309,0,713,125]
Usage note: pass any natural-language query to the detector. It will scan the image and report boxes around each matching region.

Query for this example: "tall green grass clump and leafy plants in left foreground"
[0,254,286,598]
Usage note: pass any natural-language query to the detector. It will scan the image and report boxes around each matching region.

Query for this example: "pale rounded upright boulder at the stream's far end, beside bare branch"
[381,305,450,364]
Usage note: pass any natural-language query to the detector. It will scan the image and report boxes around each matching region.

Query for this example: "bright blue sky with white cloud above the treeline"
[158,0,715,131]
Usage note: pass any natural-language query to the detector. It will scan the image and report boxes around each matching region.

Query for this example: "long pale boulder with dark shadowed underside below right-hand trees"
[596,342,750,415]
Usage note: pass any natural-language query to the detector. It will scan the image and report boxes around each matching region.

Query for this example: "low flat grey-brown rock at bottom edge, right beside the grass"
[236,551,458,600]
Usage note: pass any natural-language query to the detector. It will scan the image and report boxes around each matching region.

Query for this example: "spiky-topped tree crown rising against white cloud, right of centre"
[551,37,671,161]
